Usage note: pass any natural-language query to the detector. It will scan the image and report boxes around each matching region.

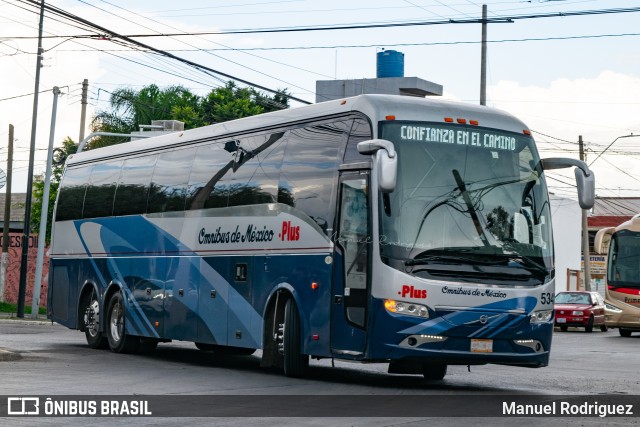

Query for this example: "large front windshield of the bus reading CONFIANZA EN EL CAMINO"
[380,121,553,285]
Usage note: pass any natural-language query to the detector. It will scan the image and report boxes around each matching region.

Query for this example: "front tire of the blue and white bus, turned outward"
[282,298,309,378]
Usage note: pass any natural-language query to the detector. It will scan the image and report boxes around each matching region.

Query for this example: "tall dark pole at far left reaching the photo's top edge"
[17,0,44,318]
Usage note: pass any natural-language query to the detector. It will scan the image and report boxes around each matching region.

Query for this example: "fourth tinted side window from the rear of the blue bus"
[147,148,196,213]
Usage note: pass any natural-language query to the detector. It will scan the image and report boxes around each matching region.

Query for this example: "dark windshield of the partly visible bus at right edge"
[608,230,640,288]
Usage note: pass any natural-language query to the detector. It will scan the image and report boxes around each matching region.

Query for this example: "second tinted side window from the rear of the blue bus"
[82,161,122,218]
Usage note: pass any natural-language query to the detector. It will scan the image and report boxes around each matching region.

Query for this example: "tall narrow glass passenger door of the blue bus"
[331,172,371,358]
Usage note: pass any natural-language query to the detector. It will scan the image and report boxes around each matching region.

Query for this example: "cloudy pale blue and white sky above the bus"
[0,0,640,202]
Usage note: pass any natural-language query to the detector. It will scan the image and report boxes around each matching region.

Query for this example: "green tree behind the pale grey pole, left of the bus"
[30,137,78,245]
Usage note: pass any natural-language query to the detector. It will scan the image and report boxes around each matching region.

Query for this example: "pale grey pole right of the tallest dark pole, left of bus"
[31,86,60,319]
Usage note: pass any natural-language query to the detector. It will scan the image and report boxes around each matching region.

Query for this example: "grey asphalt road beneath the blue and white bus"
[0,320,640,426]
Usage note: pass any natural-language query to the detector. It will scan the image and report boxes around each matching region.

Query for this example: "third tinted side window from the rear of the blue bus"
[113,155,157,216]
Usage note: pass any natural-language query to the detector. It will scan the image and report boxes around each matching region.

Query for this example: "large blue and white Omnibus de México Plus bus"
[48,95,594,379]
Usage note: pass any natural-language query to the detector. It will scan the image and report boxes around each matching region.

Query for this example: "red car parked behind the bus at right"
[554,291,607,332]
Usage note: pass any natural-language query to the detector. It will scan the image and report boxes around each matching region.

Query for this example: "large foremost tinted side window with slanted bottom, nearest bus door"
[278,121,346,234]
